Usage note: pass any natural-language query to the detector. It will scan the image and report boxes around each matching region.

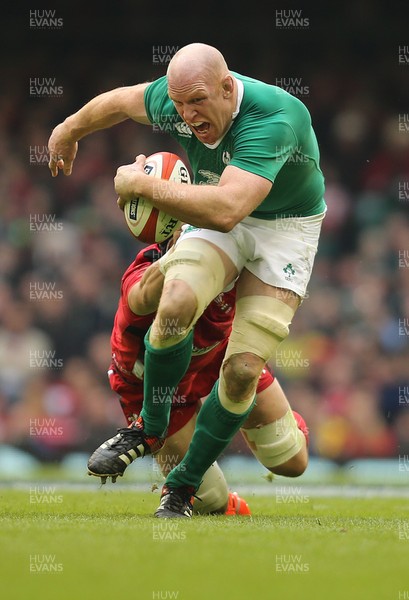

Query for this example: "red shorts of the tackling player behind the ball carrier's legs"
[109,344,274,437]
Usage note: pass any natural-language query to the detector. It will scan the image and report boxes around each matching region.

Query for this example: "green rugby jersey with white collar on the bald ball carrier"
[145,73,326,219]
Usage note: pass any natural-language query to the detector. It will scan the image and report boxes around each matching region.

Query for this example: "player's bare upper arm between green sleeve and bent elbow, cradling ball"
[219,165,273,223]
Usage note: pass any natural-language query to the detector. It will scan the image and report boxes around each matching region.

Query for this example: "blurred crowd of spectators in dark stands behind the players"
[0,1,409,464]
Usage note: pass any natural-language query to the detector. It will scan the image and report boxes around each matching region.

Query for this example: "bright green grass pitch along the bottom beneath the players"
[0,484,409,600]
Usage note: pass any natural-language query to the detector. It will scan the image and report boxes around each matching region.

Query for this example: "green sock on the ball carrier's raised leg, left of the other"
[141,330,193,437]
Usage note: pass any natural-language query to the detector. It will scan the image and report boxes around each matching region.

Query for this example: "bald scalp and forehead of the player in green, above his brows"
[167,43,229,85]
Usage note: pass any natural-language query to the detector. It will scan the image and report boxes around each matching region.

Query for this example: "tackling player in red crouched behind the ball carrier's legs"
[88,242,308,515]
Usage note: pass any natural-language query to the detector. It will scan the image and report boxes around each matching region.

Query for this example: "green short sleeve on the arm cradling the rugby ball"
[230,118,297,182]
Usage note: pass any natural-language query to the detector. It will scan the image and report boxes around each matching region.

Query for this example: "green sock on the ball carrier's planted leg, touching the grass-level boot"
[166,381,254,490]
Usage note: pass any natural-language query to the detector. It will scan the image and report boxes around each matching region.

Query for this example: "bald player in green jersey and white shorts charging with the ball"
[49,43,326,518]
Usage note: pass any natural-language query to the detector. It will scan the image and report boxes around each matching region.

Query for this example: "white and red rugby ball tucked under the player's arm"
[124,152,190,244]
